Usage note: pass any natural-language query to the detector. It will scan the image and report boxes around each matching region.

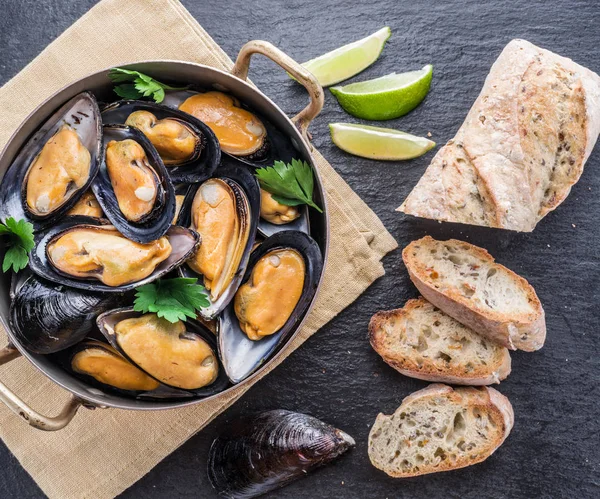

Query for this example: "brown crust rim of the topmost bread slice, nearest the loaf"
[402,236,546,352]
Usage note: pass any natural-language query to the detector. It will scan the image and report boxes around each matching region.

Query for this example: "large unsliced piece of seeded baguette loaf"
[398,40,600,231]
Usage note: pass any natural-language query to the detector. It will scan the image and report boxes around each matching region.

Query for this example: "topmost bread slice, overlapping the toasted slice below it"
[402,236,546,351]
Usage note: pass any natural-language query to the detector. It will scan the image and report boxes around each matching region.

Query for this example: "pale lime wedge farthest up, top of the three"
[302,27,392,87]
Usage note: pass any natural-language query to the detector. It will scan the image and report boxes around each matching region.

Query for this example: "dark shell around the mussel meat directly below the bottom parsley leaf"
[96,307,230,398]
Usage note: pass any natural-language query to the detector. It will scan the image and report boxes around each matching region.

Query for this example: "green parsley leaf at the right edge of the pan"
[256,159,323,213]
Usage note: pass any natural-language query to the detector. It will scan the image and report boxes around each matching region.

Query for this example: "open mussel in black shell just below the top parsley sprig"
[102,100,221,183]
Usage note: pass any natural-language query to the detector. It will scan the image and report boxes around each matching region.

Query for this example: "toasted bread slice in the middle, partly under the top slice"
[369,298,510,385]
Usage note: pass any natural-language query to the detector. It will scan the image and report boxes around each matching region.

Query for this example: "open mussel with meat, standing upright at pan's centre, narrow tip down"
[178,156,260,319]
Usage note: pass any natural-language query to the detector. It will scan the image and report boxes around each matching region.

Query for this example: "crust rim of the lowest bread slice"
[369,383,514,478]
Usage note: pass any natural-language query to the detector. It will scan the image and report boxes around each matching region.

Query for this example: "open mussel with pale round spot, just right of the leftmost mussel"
[92,125,175,243]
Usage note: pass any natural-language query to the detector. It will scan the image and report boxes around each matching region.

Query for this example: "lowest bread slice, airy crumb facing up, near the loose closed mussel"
[369,384,514,478]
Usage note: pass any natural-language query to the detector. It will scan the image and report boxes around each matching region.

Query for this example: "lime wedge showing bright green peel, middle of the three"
[330,64,433,120]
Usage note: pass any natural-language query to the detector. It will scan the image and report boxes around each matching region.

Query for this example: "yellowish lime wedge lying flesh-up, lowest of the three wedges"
[329,123,435,161]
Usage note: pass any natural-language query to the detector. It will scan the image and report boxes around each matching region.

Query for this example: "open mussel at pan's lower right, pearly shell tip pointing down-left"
[218,230,323,383]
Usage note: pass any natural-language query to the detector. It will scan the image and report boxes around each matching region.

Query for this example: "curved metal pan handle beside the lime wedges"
[231,40,324,149]
